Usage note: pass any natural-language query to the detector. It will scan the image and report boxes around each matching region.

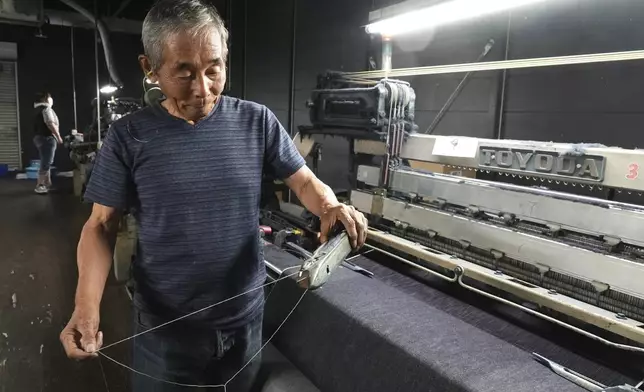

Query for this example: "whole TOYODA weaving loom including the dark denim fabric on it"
[263,75,644,391]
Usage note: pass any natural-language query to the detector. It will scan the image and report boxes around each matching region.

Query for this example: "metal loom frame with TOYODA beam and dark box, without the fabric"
[284,75,644,352]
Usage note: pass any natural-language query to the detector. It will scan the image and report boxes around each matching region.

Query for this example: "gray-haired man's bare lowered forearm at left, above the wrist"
[76,222,112,308]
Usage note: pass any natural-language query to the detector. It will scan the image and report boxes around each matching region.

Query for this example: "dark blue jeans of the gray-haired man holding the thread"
[132,311,263,392]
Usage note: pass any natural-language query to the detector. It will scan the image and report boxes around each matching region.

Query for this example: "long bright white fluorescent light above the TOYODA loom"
[367,0,544,37]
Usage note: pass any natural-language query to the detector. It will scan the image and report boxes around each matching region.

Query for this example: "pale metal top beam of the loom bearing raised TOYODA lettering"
[354,133,644,192]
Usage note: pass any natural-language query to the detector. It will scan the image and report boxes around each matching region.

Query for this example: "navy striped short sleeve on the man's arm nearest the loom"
[264,107,306,180]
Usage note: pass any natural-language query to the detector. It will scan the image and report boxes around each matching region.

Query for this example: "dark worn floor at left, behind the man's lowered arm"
[0,179,130,392]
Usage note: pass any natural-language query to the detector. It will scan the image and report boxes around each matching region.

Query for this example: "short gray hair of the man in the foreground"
[141,0,228,70]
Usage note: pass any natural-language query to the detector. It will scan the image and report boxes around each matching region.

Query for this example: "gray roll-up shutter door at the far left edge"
[0,61,22,169]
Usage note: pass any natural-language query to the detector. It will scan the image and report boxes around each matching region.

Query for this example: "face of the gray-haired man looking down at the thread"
[145,29,226,121]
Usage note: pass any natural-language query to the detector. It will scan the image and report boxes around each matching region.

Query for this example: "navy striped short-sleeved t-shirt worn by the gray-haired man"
[85,96,305,326]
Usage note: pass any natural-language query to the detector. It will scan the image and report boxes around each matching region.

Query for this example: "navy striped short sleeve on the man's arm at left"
[85,127,132,209]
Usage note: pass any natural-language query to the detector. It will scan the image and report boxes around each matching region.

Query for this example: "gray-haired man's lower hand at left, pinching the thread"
[60,306,103,360]
